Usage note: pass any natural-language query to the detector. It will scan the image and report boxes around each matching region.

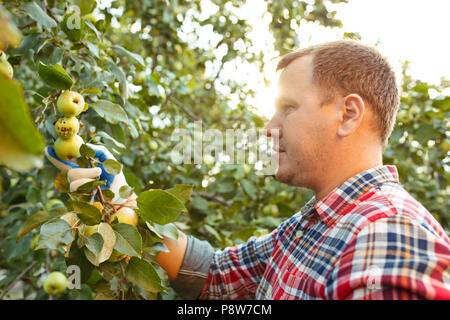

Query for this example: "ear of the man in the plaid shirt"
[337,93,366,138]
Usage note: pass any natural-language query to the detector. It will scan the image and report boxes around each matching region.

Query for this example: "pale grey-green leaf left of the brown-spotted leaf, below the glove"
[36,219,73,249]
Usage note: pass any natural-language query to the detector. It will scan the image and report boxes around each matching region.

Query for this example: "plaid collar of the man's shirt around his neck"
[301,165,398,227]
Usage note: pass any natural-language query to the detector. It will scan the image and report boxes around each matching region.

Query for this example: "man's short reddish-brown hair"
[277,40,399,146]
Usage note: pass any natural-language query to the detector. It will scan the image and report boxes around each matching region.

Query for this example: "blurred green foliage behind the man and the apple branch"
[0,0,450,299]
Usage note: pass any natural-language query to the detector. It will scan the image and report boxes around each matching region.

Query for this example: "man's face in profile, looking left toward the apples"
[266,56,337,188]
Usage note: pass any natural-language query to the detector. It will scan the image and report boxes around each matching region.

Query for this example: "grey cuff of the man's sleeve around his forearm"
[170,236,214,300]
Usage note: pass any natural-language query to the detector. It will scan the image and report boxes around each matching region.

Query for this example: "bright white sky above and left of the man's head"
[241,0,450,117]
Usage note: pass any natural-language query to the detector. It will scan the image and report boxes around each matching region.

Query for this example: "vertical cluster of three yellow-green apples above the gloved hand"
[55,91,85,161]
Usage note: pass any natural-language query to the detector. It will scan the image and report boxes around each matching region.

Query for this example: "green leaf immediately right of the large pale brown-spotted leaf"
[113,223,142,257]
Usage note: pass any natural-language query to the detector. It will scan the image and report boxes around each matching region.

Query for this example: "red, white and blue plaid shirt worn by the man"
[200,166,450,299]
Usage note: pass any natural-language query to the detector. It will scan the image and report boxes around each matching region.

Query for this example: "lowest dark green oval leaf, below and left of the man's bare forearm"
[125,258,164,292]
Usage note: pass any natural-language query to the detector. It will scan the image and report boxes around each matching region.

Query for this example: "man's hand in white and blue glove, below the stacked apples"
[44,144,136,203]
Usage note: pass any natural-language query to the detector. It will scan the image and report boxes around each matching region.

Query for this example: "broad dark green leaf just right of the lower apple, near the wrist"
[136,190,187,224]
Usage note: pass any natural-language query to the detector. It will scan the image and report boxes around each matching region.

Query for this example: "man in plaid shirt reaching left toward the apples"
[47,41,450,299]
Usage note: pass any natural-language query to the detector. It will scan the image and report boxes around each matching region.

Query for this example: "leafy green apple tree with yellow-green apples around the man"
[0,0,450,299]
